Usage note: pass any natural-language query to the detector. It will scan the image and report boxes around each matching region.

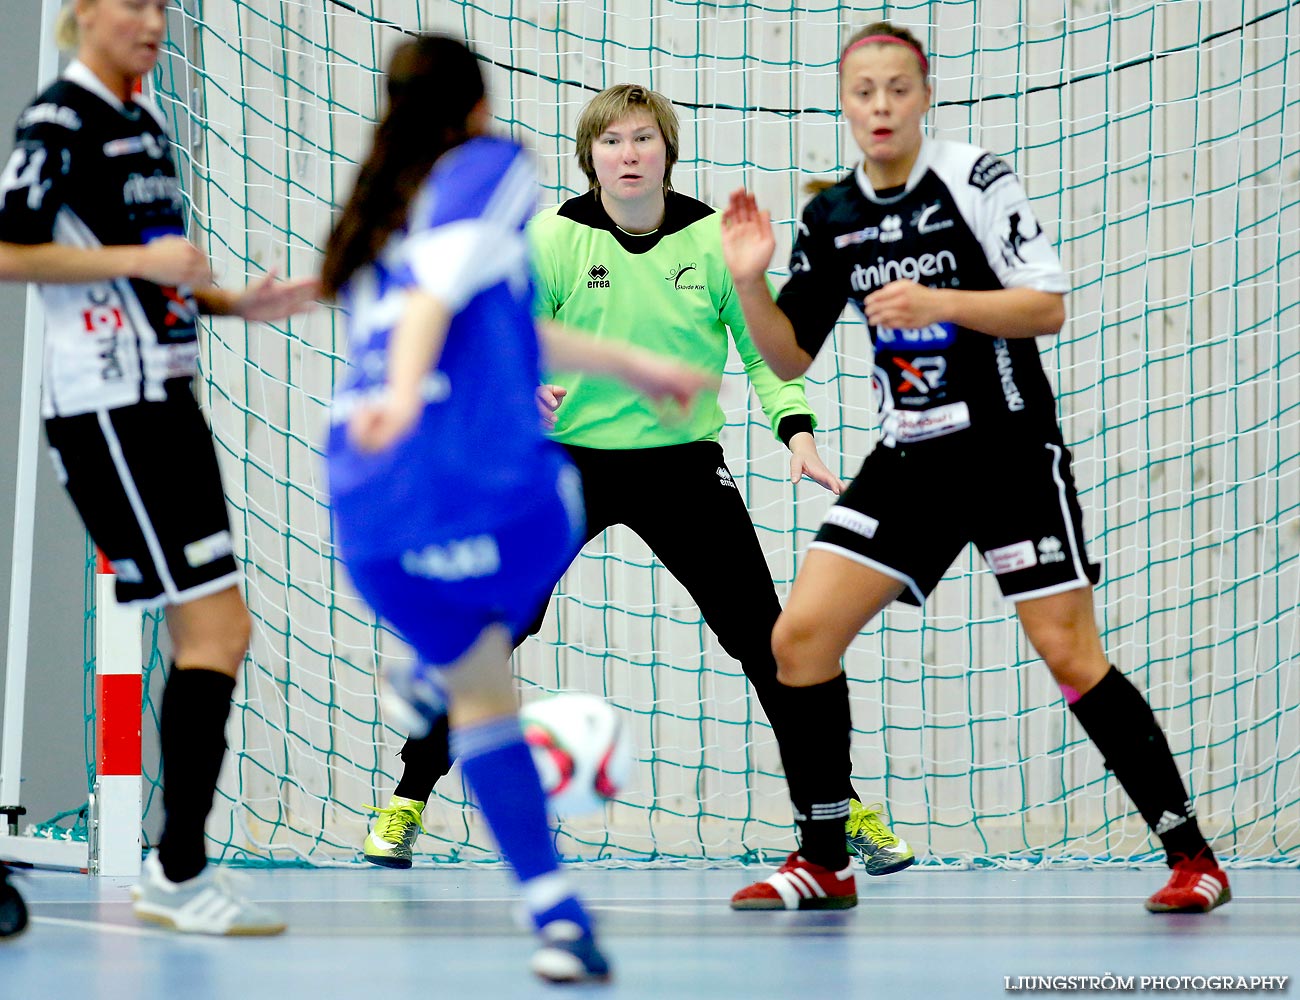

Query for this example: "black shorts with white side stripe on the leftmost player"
[46,378,239,605]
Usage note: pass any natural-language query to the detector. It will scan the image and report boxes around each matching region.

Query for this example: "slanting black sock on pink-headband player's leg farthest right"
[1070,667,1208,865]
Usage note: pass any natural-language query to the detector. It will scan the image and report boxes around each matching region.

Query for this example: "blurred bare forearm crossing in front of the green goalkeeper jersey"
[538,320,718,407]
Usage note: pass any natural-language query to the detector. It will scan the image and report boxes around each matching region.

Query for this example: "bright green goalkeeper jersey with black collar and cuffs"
[528,191,815,449]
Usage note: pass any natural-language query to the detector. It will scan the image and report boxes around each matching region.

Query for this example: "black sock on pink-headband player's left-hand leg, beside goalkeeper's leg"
[776,674,853,871]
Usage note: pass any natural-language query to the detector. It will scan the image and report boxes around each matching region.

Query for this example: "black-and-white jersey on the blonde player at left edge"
[0,62,198,417]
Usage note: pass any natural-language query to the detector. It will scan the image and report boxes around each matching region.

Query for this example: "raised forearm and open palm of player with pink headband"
[723,190,813,380]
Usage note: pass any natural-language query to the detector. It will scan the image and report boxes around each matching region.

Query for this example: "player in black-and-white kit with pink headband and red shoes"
[723,23,1230,912]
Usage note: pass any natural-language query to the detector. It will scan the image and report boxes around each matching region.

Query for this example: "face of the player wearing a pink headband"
[840,44,930,165]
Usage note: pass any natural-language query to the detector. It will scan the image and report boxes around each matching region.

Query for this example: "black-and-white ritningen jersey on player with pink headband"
[777,139,1069,446]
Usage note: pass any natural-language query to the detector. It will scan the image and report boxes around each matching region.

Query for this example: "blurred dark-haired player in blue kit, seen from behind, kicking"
[321,36,707,982]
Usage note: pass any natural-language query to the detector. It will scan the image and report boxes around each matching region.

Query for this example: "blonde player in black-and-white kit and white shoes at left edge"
[0,0,316,934]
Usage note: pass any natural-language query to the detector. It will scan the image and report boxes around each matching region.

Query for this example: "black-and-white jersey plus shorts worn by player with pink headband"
[779,140,1100,605]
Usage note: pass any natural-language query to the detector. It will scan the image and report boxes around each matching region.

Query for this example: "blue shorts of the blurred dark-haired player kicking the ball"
[347,462,584,667]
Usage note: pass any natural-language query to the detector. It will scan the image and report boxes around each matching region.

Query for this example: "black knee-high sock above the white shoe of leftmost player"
[159,664,235,882]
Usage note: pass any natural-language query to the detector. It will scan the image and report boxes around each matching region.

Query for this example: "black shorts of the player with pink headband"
[813,438,1101,606]
